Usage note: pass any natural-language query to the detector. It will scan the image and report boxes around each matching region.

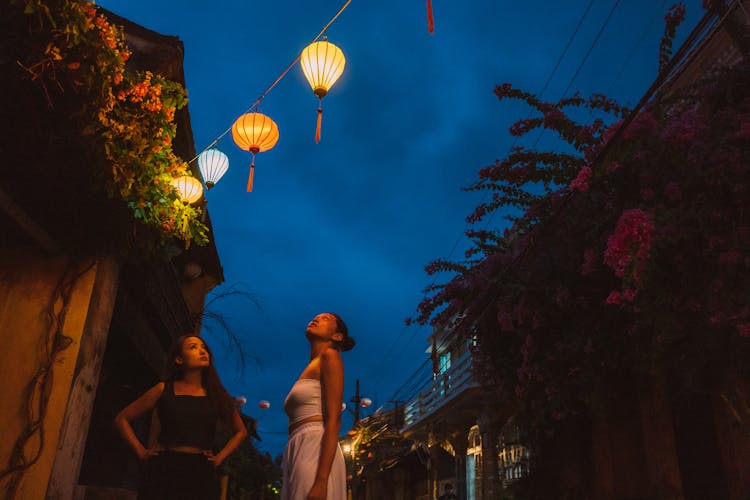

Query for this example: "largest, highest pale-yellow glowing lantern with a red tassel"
[300,40,346,144]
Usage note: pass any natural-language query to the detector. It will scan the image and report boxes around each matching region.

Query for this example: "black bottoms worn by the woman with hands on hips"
[138,450,221,500]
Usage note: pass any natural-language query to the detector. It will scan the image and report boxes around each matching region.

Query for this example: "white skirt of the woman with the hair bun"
[281,422,346,500]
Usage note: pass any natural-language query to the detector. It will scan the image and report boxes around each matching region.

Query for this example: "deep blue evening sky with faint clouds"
[97,0,704,455]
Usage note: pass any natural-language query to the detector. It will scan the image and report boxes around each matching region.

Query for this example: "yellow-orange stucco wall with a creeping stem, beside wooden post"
[0,250,97,500]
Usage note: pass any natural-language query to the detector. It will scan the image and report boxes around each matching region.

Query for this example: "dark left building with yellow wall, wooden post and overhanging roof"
[0,5,224,500]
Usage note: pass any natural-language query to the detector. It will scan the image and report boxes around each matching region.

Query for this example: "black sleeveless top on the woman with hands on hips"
[156,381,219,450]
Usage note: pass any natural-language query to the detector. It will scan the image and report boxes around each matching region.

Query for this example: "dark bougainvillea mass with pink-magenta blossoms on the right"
[416,0,750,434]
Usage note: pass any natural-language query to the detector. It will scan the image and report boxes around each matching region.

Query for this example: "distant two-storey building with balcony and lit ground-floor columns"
[401,322,528,500]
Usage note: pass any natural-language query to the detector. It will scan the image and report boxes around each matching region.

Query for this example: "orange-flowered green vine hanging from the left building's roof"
[19,0,208,245]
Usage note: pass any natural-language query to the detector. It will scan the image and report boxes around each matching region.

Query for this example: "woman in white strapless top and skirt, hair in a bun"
[281,313,354,500]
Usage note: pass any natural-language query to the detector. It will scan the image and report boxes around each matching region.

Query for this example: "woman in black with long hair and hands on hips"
[115,335,247,500]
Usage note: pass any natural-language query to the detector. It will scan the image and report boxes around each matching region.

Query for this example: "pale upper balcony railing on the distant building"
[404,350,479,429]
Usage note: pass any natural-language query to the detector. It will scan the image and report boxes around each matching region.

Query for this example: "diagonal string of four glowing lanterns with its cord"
[173,0,351,204]
